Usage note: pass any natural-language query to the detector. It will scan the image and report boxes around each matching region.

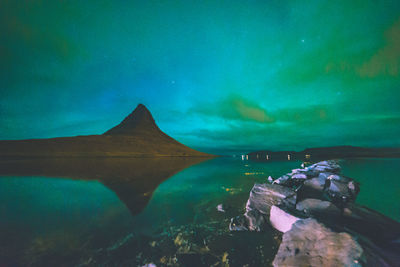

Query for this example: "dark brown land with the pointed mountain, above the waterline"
[0,104,213,158]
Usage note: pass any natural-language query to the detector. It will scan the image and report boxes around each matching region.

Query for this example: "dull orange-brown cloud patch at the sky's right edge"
[357,19,400,77]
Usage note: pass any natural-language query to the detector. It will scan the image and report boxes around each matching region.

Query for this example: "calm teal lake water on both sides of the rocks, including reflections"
[0,158,400,266]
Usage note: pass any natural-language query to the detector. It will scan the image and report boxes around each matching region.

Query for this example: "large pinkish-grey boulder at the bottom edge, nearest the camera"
[273,219,363,267]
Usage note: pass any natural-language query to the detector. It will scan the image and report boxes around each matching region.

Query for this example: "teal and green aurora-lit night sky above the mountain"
[0,0,400,153]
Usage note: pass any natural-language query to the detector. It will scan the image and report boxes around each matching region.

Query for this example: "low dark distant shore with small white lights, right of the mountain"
[247,146,400,161]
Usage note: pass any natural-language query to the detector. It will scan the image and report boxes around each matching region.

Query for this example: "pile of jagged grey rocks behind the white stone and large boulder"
[230,160,359,231]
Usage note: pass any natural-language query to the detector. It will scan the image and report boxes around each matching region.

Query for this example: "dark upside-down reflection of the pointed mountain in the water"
[0,157,207,215]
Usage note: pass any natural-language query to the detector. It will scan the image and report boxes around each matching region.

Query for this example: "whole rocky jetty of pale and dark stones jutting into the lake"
[229,160,400,266]
